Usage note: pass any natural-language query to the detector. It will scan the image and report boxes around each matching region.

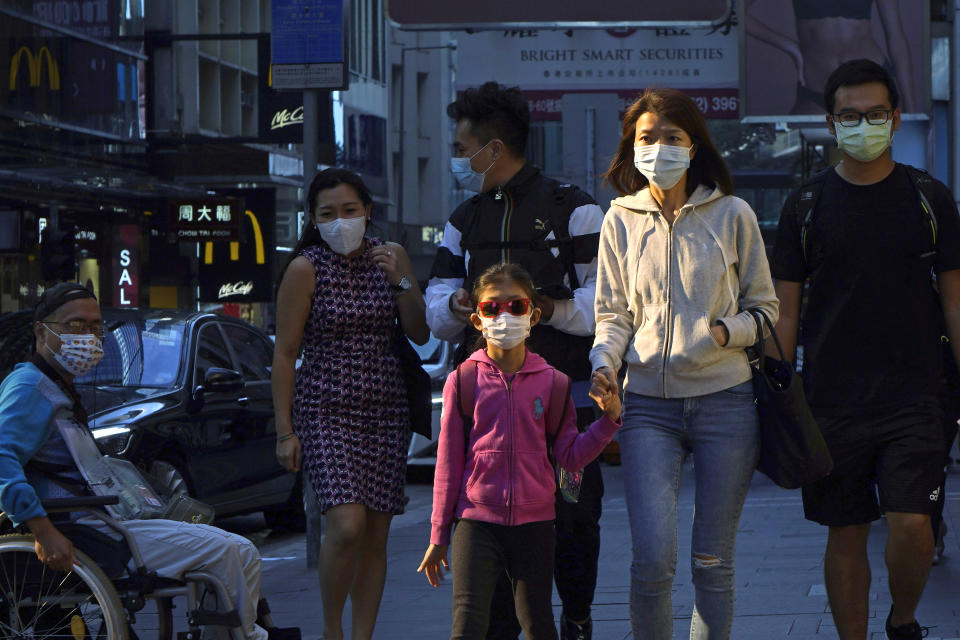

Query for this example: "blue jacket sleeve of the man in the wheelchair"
[0,370,57,524]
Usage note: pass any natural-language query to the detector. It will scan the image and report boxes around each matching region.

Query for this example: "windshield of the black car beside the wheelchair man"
[75,318,184,387]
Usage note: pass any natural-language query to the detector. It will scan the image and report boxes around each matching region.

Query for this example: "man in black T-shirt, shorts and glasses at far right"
[773,60,960,640]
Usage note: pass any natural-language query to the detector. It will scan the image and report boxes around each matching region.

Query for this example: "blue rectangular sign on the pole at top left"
[270,0,347,89]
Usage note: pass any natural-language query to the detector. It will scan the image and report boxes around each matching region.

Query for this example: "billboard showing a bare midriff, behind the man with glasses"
[740,0,930,122]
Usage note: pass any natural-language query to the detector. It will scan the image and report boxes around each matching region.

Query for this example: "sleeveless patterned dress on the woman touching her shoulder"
[293,238,410,514]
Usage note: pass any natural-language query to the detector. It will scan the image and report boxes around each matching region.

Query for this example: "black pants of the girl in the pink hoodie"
[450,520,557,640]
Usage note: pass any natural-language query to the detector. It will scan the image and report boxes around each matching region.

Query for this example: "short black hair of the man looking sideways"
[447,82,530,158]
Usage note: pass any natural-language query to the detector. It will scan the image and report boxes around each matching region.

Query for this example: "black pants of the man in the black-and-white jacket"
[486,409,603,640]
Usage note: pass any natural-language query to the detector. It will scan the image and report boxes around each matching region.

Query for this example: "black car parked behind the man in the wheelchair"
[75,309,303,528]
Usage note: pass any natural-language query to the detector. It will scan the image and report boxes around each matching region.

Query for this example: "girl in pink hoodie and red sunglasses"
[417,263,620,640]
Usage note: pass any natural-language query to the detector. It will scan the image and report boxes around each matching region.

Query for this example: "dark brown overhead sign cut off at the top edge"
[387,0,733,30]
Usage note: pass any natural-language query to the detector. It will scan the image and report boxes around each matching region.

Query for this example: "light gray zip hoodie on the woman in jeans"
[590,185,779,398]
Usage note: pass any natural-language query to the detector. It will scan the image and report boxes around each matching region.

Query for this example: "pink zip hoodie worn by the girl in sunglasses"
[430,349,620,545]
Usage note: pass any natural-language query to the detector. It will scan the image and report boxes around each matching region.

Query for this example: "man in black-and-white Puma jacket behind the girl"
[426,82,603,640]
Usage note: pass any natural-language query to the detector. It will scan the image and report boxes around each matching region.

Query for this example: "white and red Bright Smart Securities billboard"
[457,28,739,120]
